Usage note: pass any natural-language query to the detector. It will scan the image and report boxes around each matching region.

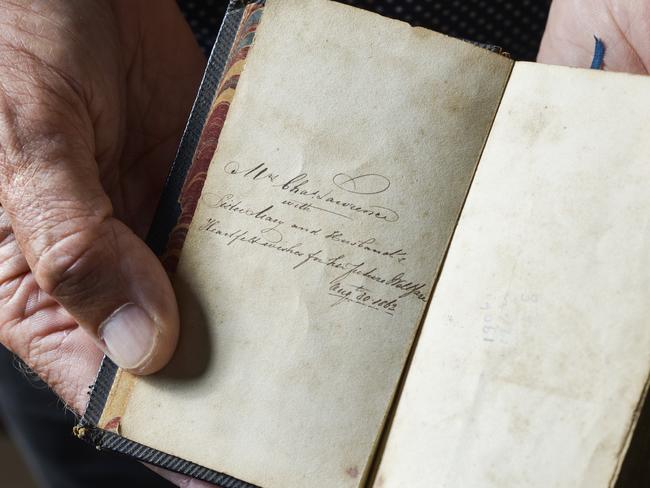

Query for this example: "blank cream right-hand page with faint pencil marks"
[374,63,650,488]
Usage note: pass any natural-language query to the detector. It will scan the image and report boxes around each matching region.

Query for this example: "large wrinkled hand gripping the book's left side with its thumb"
[0,0,205,413]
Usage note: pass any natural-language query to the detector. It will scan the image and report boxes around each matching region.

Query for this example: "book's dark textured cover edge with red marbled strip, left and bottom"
[73,0,265,488]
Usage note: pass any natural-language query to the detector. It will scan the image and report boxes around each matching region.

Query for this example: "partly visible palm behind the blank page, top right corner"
[537,0,650,74]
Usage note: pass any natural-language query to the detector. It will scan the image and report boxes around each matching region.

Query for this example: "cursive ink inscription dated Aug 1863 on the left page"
[199,161,429,316]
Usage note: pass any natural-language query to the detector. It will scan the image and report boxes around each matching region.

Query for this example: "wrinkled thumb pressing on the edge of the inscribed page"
[0,71,178,374]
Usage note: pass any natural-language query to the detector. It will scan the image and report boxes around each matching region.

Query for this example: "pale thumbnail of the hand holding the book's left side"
[99,303,158,369]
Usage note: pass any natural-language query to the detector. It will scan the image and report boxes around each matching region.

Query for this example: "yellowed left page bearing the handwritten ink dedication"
[97,0,512,488]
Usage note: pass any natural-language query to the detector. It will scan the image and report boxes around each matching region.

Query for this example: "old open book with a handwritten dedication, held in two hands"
[77,0,650,488]
